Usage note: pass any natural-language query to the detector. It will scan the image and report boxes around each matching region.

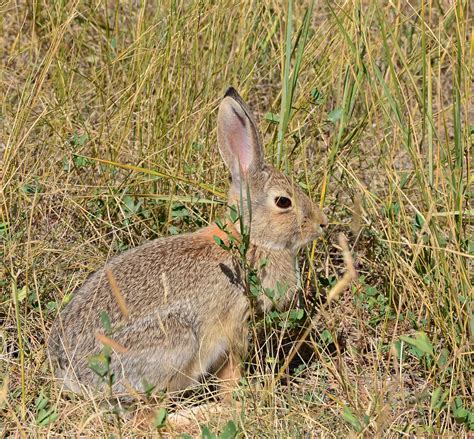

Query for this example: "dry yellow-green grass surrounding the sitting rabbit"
[0,0,474,437]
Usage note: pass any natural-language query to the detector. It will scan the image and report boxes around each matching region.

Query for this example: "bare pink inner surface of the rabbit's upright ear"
[226,114,252,175]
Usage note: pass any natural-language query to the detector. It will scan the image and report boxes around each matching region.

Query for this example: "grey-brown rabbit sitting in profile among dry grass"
[48,88,327,400]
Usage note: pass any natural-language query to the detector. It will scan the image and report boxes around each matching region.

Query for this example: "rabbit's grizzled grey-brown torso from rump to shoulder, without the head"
[49,228,248,396]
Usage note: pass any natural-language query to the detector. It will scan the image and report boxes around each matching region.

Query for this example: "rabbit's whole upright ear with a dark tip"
[217,87,264,181]
